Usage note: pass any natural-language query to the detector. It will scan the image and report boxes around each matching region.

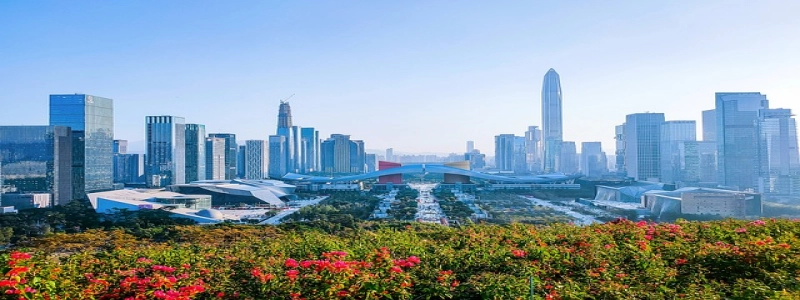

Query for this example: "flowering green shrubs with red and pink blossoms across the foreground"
[0,220,800,299]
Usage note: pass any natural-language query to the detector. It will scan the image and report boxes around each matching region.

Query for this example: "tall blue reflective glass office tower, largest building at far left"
[50,94,114,199]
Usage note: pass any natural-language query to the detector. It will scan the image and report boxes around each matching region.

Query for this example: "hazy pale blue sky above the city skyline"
[0,0,800,155]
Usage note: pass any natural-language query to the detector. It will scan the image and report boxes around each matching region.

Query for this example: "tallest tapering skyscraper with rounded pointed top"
[542,69,564,173]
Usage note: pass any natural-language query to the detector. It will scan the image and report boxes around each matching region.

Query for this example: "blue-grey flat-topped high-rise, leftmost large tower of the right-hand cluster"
[623,113,664,181]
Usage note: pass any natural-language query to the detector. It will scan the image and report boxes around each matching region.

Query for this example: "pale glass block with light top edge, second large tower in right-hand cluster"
[660,121,700,186]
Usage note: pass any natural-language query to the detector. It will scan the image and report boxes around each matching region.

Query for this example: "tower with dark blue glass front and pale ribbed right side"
[145,116,186,187]
